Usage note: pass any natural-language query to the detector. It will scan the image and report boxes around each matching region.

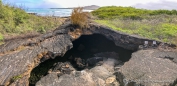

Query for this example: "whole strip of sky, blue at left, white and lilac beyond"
[2,0,177,9]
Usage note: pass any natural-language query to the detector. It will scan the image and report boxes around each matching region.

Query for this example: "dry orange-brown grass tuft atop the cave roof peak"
[71,7,88,28]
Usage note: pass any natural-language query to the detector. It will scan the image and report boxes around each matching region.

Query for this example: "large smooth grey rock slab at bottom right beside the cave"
[116,49,177,86]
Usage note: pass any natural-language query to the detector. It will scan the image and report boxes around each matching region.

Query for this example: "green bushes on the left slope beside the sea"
[0,0,62,43]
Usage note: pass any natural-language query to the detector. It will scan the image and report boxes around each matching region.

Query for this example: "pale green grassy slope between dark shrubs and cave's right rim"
[95,16,177,43]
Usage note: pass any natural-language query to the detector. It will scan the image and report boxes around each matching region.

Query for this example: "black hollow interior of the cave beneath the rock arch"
[70,34,134,62]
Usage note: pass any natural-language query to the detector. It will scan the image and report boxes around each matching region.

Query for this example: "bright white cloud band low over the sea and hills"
[38,0,162,7]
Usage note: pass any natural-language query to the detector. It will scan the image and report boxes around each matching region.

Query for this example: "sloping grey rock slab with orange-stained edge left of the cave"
[0,29,72,86]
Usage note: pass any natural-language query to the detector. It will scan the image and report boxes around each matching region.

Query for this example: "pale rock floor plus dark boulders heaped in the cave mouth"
[36,53,121,86]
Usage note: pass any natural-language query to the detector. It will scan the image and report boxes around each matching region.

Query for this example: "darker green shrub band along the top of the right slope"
[92,6,177,19]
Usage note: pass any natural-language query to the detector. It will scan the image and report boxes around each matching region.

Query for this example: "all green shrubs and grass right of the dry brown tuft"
[92,6,177,43]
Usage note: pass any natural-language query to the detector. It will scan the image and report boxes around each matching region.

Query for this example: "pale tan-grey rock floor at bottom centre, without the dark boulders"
[36,57,119,86]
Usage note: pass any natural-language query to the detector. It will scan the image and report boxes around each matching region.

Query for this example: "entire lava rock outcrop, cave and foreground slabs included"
[0,22,177,86]
